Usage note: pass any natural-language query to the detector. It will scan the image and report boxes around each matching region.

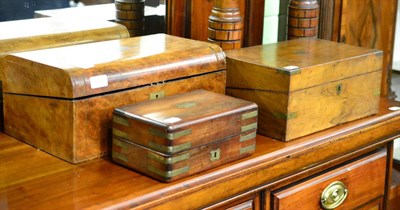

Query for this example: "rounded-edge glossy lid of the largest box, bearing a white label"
[0,34,225,99]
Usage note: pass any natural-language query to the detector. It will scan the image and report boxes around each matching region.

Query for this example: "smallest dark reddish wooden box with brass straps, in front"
[112,90,258,182]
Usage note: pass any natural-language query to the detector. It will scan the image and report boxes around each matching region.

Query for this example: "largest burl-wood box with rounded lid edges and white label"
[0,34,226,163]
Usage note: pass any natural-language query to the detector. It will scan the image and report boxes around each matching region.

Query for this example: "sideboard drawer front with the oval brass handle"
[272,150,386,210]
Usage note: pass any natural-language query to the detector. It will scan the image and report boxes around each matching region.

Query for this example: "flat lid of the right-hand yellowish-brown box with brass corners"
[226,38,383,93]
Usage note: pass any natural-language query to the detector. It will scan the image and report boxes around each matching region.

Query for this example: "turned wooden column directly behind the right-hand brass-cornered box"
[288,0,319,39]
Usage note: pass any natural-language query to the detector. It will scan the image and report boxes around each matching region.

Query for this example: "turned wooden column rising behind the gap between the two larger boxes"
[208,0,243,50]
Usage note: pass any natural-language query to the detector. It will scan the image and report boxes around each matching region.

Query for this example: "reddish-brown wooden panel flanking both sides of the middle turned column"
[167,0,264,46]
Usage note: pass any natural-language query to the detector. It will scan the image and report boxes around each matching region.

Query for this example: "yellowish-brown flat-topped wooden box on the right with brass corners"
[226,38,382,141]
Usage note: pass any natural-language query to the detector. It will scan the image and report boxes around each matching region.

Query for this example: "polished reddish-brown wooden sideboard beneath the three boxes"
[0,99,400,209]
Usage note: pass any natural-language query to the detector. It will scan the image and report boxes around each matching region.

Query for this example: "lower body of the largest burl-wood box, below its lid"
[4,71,226,163]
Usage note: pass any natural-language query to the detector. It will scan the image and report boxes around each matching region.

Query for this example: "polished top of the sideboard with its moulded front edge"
[0,99,400,209]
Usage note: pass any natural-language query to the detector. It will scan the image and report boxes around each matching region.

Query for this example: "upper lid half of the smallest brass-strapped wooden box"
[113,90,258,154]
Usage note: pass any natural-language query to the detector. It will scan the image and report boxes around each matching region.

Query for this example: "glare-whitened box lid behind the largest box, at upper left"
[0,18,129,56]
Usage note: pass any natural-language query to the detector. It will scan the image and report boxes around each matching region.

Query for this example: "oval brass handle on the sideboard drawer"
[321,181,348,209]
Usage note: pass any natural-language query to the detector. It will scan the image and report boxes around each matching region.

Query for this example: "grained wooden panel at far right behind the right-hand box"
[340,0,397,96]
